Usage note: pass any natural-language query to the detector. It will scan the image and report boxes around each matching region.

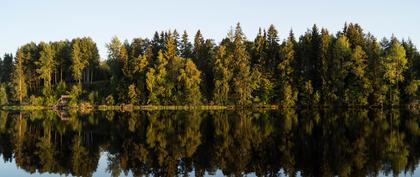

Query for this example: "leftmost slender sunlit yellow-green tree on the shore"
[11,49,27,104]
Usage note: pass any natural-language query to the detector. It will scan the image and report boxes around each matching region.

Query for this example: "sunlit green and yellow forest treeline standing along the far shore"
[0,23,420,107]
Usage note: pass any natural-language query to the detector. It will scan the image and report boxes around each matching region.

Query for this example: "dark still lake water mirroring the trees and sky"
[0,109,420,176]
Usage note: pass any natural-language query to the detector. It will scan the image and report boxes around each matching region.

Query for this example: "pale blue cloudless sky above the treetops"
[0,0,420,58]
